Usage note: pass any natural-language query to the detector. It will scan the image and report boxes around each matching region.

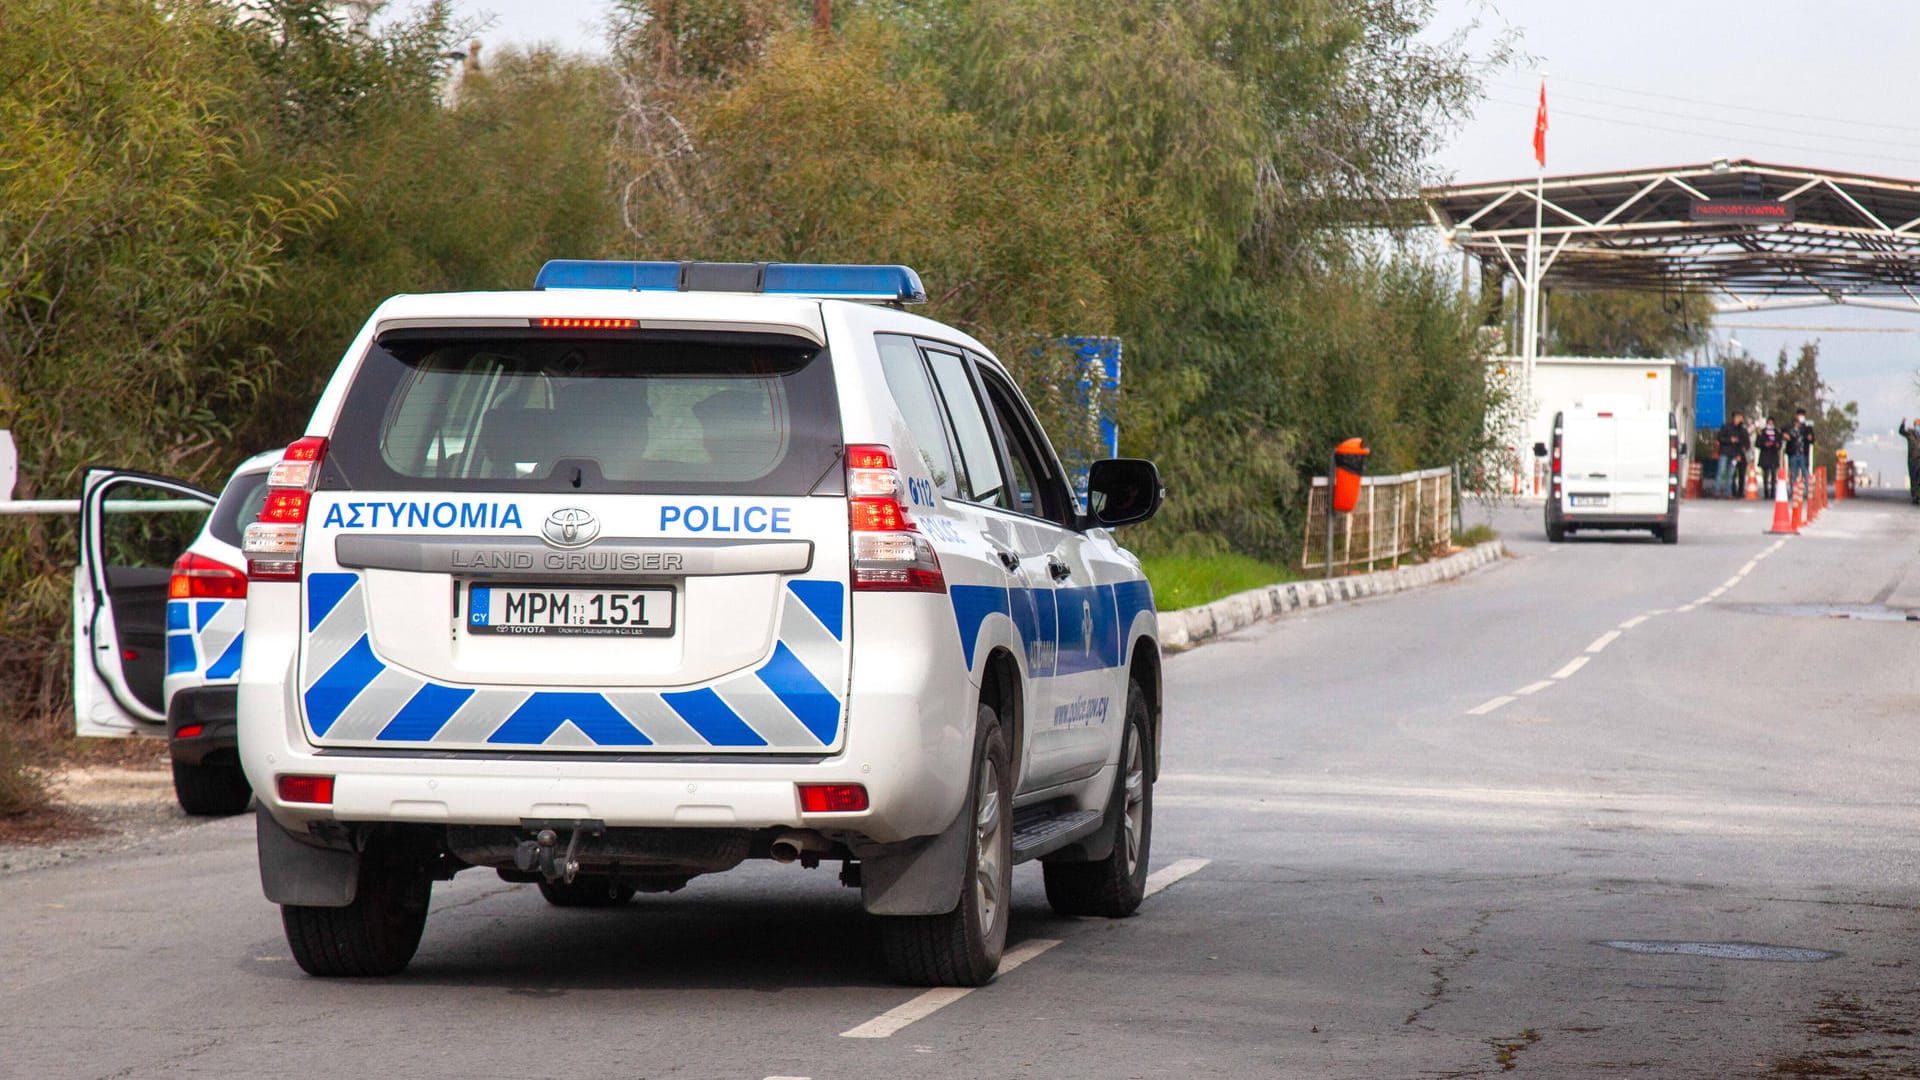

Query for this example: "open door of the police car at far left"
[73,469,217,736]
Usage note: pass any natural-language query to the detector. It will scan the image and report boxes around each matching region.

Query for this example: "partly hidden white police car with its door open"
[73,452,280,815]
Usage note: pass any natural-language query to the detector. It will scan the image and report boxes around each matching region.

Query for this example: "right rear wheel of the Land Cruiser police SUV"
[879,705,1014,986]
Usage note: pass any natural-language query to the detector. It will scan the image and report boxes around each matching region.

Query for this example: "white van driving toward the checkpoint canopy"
[1546,400,1680,544]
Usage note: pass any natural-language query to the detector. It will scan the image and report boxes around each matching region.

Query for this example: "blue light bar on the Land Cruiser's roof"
[534,259,927,304]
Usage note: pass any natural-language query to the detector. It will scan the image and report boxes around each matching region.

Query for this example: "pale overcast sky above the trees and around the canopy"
[441,0,1920,470]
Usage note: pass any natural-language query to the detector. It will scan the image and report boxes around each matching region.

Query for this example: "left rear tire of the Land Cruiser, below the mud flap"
[280,849,434,978]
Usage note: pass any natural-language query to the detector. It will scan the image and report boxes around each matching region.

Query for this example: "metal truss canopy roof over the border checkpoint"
[1421,160,1920,311]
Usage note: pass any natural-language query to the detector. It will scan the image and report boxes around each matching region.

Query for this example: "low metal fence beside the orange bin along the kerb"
[1300,469,1453,571]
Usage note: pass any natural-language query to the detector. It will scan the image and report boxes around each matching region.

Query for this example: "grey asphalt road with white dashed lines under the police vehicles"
[0,500,1920,1080]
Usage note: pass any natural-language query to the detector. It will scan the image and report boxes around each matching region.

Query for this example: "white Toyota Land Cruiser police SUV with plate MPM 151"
[240,261,1162,984]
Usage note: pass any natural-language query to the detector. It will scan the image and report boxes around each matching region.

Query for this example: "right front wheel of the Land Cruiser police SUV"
[1041,682,1154,919]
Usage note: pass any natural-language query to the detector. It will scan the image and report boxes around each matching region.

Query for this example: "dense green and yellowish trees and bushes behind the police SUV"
[0,0,1505,811]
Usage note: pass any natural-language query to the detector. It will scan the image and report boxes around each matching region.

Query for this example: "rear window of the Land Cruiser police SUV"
[323,331,841,494]
